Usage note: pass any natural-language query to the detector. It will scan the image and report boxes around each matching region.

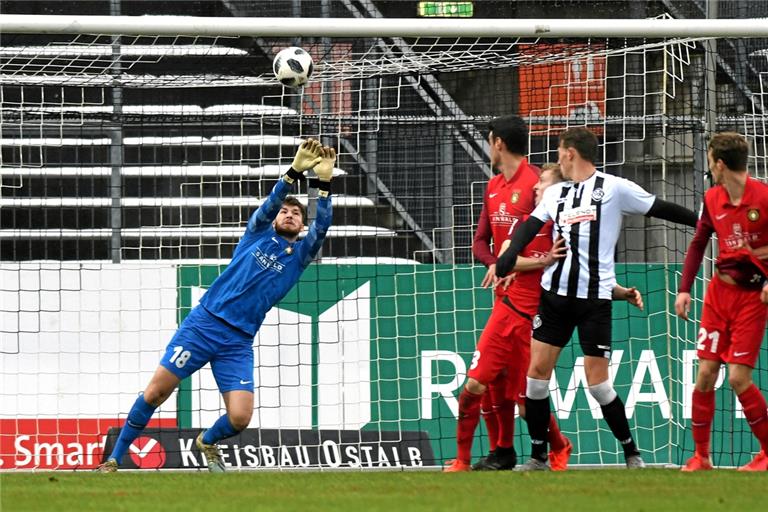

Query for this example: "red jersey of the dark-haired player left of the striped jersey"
[472,159,541,267]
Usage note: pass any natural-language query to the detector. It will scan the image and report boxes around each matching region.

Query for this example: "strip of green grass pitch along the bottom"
[0,469,768,512]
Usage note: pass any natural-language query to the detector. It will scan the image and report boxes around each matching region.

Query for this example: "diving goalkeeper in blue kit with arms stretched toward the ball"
[98,139,336,473]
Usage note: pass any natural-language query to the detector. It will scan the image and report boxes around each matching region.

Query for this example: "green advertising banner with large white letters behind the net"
[178,264,768,465]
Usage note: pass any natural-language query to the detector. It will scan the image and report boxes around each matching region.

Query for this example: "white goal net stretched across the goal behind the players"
[0,12,768,470]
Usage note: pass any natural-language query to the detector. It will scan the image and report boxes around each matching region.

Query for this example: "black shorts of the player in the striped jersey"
[533,290,613,358]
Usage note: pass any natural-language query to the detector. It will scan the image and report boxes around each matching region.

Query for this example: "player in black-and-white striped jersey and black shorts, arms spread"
[496,128,696,470]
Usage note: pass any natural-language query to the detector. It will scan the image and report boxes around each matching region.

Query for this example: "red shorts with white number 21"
[696,274,768,368]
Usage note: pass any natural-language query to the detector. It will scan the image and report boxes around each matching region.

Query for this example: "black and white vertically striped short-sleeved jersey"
[531,171,656,299]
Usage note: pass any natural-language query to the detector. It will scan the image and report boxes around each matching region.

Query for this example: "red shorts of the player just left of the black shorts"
[467,298,531,400]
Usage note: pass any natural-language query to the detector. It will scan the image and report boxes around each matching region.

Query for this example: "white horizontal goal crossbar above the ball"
[0,14,768,38]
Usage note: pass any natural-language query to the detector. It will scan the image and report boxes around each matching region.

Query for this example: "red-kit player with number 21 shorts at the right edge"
[675,132,768,471]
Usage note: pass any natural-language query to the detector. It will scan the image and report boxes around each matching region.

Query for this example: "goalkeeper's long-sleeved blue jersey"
[200,180,332,336]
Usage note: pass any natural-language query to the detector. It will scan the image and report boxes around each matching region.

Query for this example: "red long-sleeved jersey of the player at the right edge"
[680,177,768,292]
